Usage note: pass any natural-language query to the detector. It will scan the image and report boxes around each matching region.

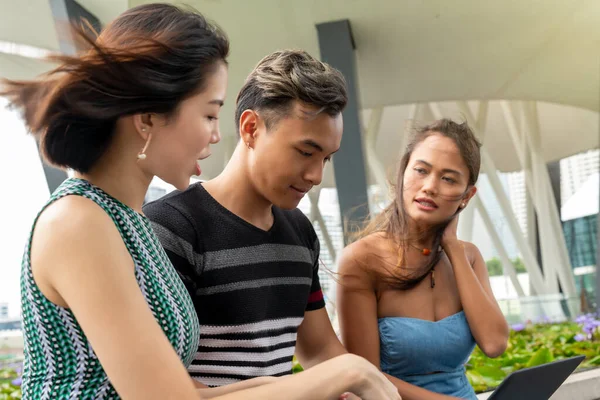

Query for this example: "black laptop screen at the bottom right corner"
[488,356,585,400]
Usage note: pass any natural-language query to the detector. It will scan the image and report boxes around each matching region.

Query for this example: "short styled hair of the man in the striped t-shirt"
[235,50,348,134]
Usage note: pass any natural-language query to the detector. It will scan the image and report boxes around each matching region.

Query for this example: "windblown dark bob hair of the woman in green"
[0,4,229,173]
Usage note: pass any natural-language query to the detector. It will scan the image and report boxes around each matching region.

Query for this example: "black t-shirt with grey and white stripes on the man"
[144,183,325,386]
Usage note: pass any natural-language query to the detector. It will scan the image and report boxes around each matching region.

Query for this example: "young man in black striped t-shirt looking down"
[144,51,347,386]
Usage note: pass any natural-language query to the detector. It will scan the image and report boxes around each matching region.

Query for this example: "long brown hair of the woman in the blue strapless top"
[355,119,481,290]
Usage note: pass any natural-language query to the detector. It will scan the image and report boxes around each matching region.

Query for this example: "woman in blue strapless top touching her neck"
[337,119,508,399]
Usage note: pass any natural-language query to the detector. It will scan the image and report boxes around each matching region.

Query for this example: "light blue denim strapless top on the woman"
[379,311,477,400]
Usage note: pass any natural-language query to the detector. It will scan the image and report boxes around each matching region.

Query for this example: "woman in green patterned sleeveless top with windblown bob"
[0,4,399,400]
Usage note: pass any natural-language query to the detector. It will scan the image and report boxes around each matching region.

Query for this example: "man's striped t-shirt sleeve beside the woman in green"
[144,200,204,298]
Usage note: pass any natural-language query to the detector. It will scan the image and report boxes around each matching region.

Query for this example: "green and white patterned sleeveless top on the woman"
[21,178,199,400]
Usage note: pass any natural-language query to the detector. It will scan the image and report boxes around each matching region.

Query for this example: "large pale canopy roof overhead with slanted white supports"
[0,0,600,312]
